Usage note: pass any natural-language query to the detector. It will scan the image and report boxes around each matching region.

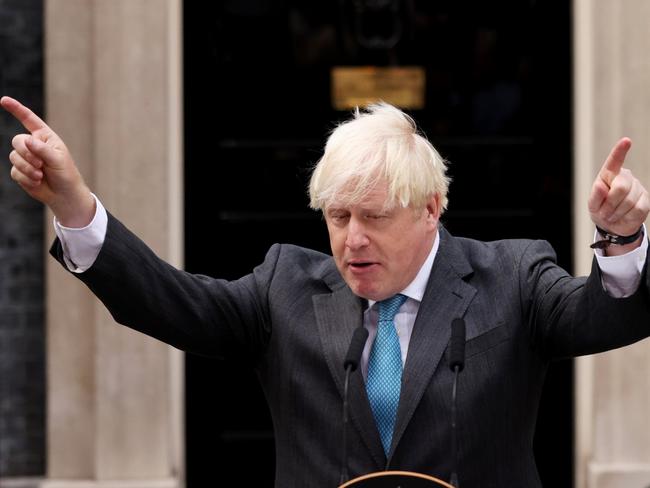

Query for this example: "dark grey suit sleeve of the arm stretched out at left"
[50,214,280,359]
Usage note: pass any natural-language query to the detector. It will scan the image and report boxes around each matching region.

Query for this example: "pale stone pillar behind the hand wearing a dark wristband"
[574,0,650,488]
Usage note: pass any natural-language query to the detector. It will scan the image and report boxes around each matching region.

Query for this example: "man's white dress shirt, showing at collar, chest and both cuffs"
[54,195,648,378]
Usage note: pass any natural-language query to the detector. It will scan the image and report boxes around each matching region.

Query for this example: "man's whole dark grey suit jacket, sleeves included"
[52,216,650,488]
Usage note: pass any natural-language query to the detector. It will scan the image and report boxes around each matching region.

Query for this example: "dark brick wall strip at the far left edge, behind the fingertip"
[0,0,45,478]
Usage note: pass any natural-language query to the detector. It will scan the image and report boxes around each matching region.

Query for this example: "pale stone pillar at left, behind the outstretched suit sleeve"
[42,0,183,488]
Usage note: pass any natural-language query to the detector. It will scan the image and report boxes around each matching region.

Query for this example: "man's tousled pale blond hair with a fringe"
[309,102,450,212]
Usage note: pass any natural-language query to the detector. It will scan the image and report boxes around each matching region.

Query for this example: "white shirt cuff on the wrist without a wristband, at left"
[53,194,108,273]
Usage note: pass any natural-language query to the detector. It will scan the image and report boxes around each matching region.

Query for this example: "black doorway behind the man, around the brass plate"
[184,0,573,488]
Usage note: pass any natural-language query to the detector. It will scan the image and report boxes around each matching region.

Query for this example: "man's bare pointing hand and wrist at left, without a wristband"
[0,97,95,227]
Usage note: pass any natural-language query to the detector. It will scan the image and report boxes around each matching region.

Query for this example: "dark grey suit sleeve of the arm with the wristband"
[518,241,650,358]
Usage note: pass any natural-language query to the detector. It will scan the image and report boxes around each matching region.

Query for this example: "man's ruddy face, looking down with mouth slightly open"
[325,182,440,301]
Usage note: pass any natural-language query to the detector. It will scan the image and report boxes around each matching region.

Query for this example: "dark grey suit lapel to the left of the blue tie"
[313,286,386,469]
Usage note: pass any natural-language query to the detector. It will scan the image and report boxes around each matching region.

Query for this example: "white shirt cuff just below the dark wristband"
[594,225,648,298]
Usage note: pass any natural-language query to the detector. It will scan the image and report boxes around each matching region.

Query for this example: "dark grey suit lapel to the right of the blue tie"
[389,228,476,463]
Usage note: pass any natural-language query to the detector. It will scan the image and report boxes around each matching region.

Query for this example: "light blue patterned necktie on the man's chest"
[366,295,406,455]
